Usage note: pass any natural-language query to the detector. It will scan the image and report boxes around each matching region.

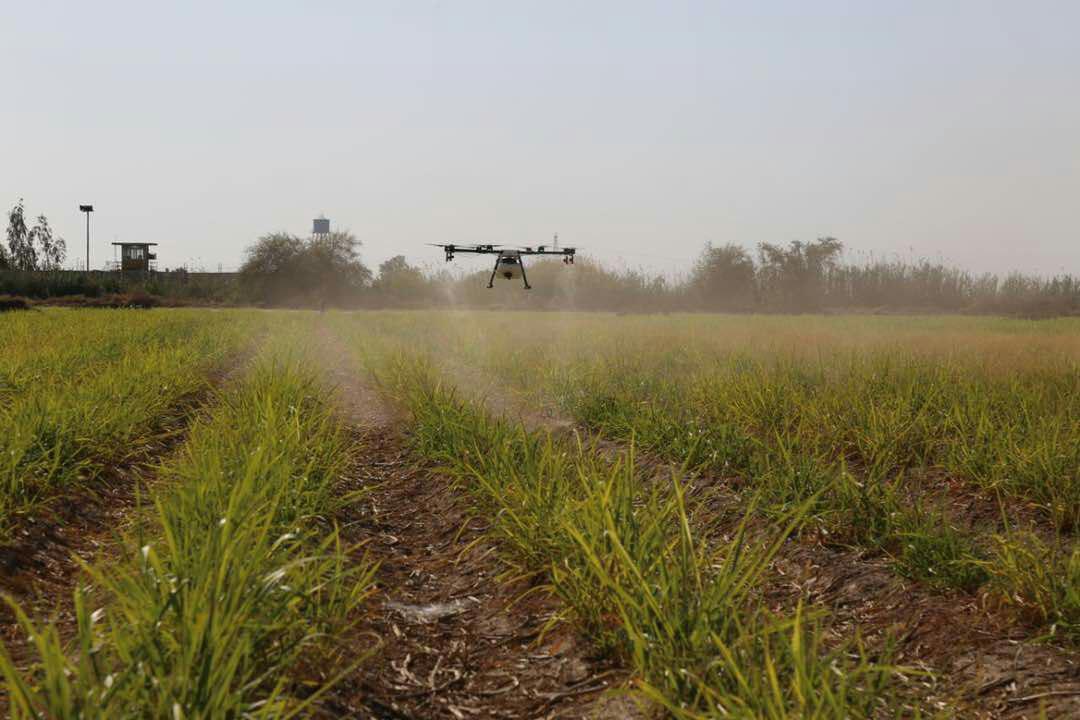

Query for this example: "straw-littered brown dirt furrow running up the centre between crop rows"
[320,328,635,720]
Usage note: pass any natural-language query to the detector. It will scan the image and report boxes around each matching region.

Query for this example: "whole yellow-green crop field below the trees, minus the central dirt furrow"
[0,310,1080,718]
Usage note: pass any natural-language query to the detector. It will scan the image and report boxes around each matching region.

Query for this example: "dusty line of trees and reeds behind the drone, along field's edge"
[232,232,1080,315]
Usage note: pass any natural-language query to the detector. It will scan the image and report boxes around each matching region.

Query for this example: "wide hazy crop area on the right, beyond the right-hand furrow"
[332,313,1080,637]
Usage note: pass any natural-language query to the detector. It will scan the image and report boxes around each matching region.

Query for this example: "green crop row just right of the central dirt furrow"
[369,355,892,719]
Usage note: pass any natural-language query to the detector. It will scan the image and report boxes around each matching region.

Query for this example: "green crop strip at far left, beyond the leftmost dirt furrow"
[0,311,253,532]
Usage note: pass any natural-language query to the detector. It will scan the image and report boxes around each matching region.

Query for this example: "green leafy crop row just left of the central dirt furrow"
[0,340,374,718]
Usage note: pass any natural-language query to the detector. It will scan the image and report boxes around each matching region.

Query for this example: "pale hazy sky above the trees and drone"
[0,0,1080,273]
